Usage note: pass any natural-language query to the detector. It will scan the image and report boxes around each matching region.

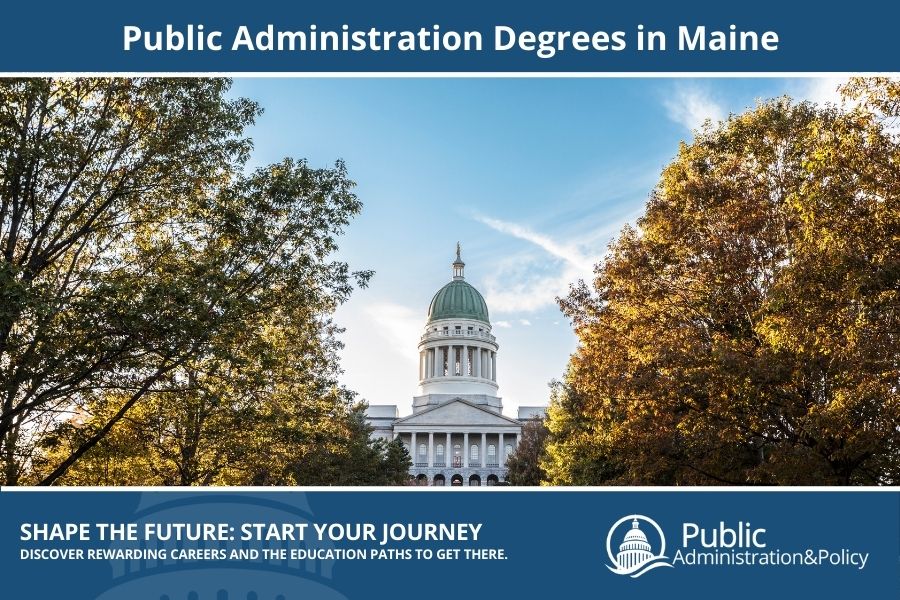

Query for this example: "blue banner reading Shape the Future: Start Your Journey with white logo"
[0,489,900,600]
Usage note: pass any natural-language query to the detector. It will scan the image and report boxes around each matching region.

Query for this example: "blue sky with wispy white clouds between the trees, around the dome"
[233,78,840,414]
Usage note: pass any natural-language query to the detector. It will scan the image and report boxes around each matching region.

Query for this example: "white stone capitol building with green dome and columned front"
[367,244,544,486]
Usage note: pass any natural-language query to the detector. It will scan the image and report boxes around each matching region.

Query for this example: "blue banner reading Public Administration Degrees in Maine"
[0,0,900,73]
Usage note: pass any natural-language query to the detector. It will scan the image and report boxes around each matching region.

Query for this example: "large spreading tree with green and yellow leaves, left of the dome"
[0,78,369,485]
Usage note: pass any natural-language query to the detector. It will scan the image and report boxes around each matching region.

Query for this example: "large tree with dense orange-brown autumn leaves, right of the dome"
[545,79,900,485]
